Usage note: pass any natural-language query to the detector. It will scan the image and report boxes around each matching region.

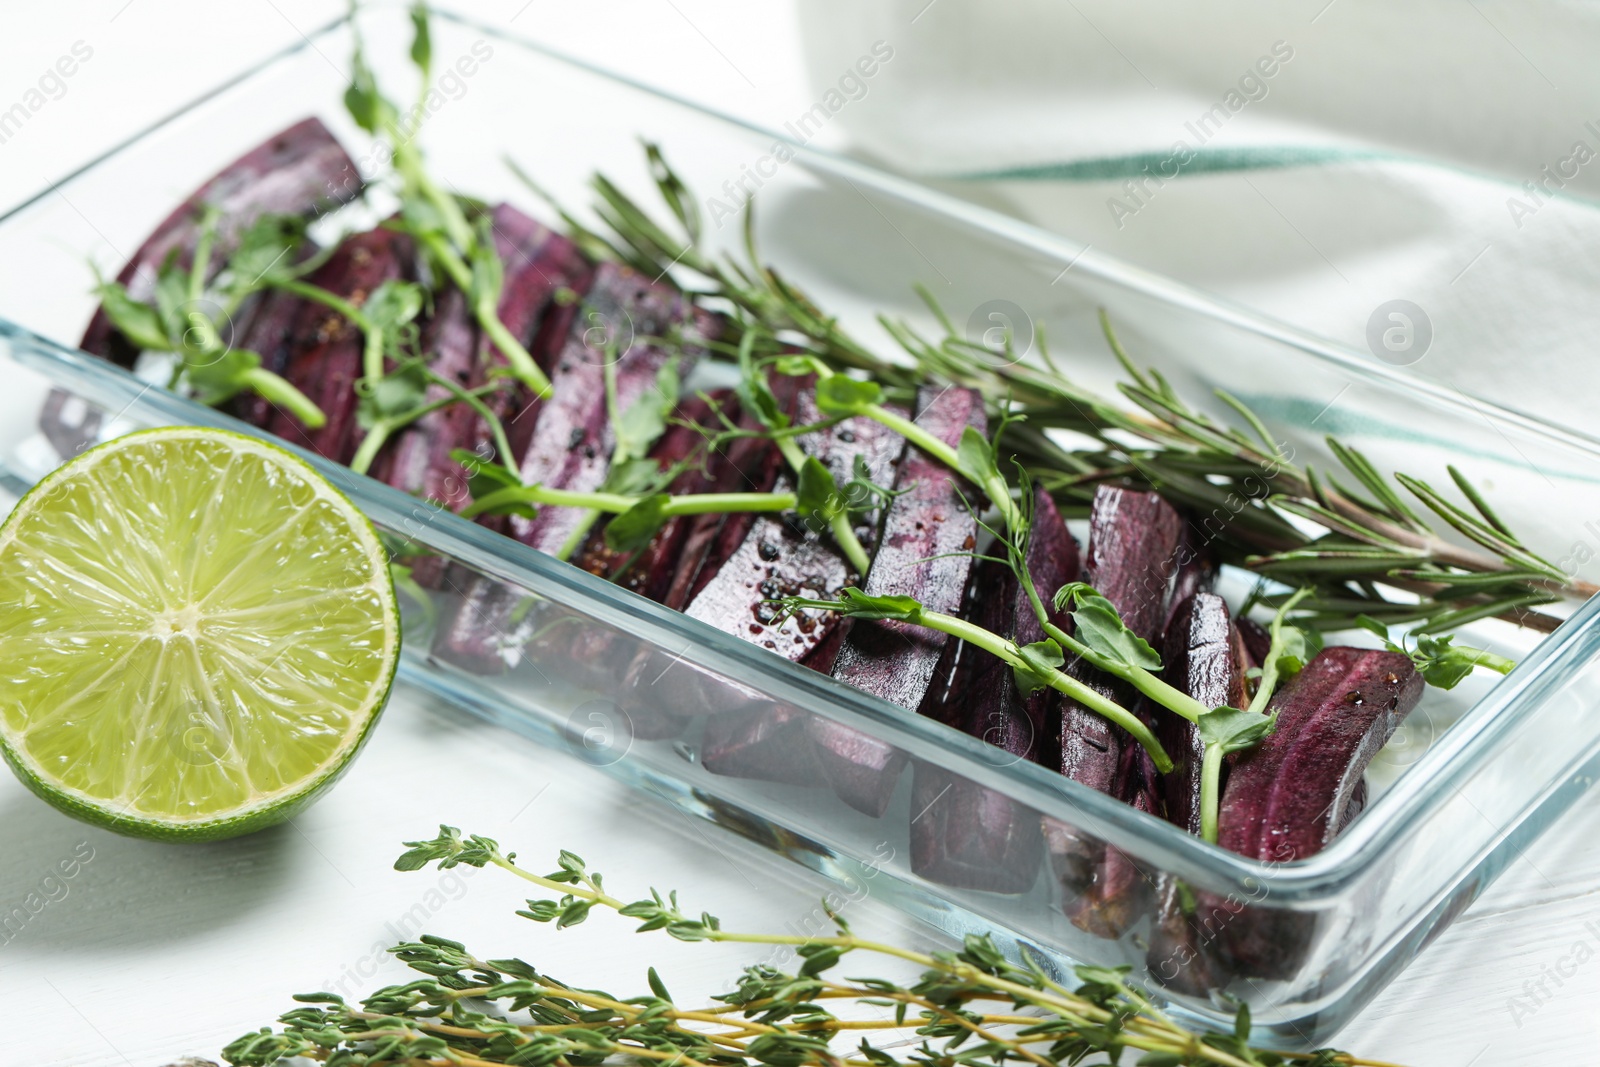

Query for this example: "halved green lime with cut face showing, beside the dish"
[0,427,400,840]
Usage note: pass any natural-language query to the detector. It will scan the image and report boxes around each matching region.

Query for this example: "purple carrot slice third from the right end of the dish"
[1045,485,1184,933]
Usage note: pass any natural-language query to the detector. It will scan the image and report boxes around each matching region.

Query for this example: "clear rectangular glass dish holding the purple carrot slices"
[0,8,1600,1046]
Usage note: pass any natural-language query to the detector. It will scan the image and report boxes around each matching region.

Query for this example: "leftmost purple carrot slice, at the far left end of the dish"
[78,118,362,366]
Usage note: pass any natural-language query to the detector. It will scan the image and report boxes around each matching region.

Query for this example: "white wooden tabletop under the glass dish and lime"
[0,0,1600,1067]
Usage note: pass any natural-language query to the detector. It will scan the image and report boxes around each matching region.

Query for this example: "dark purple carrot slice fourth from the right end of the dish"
[910,490,1078,893]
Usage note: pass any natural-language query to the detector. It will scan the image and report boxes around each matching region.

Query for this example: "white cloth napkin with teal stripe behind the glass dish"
[800,0,1600,441]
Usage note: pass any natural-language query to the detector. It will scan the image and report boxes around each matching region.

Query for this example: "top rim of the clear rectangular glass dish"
[0,2,1600,904]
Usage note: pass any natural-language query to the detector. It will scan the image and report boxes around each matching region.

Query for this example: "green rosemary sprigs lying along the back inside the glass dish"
[560,144,1600,632]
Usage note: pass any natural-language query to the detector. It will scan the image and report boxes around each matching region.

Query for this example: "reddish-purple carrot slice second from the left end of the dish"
[267,229,411,462]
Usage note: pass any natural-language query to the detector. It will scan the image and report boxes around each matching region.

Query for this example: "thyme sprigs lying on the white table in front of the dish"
[222,825,1386,1067]
